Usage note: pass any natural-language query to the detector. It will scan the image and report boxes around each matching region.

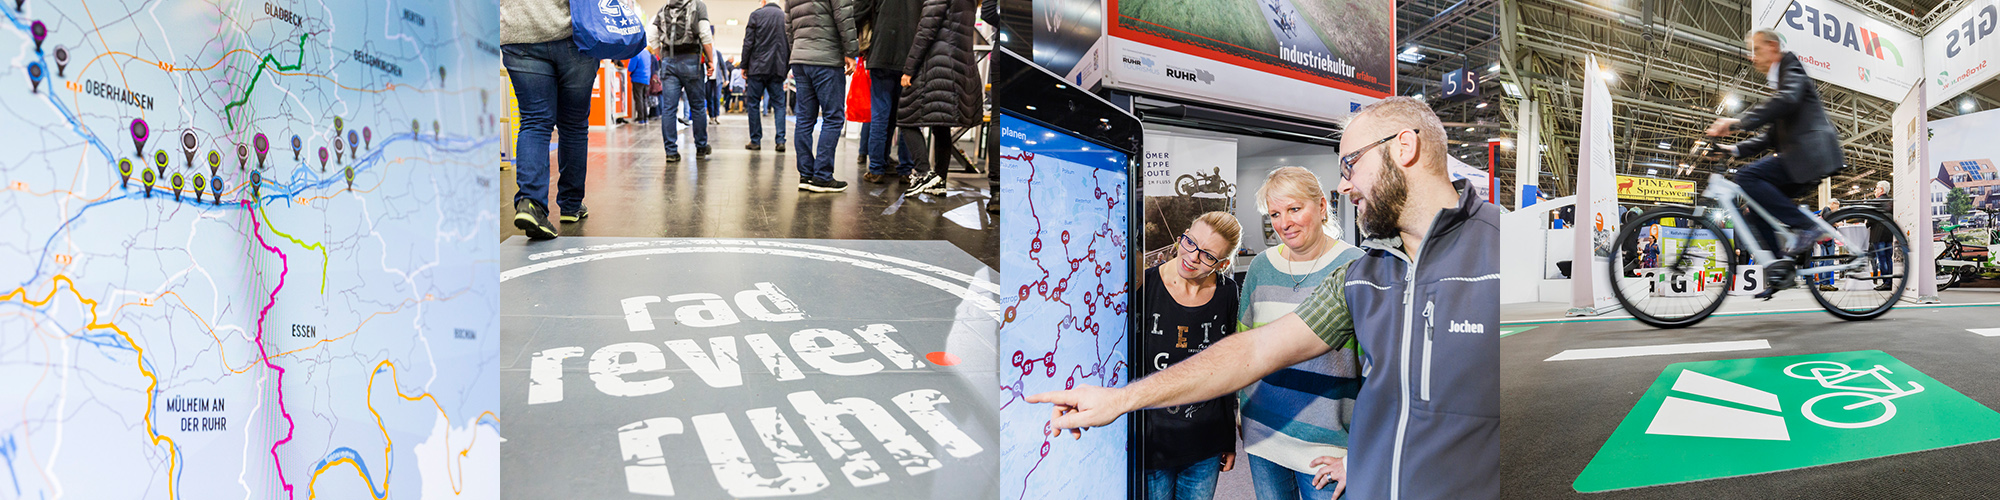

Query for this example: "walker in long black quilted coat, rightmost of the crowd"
[896,0,982,196]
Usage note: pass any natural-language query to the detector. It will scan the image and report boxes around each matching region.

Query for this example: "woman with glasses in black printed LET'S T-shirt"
[1138,212,1242,500]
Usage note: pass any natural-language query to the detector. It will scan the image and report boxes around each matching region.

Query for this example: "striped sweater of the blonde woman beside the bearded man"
[1236,240,1362,474]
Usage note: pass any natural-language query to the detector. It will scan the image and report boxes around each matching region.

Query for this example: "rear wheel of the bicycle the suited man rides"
[1800,206,1910,322]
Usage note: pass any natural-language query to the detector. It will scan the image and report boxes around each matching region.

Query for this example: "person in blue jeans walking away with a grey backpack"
[646,0,716,164]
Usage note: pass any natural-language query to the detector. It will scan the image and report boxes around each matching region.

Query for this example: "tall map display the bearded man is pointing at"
[998,114,1130,500]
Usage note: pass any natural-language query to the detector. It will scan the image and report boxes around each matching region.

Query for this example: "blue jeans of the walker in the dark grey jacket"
[792,64,848,180]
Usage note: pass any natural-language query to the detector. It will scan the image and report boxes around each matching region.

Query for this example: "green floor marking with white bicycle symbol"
[1572,350,2000,492]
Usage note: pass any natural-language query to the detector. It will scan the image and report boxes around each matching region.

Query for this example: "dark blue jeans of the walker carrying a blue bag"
[500,38,598,212]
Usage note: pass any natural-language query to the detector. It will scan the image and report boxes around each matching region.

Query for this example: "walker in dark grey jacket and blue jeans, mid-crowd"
[786,0,860,192]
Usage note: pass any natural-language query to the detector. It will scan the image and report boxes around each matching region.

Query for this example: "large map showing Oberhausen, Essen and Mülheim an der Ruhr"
[0,0,504,500]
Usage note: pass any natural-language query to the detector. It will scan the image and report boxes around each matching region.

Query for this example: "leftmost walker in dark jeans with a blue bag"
[500,0,598,240]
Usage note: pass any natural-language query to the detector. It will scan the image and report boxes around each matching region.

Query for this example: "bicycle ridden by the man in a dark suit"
[1606,146,1910,328]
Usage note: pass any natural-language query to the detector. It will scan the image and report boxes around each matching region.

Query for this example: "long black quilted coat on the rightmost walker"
[896,0,984,128]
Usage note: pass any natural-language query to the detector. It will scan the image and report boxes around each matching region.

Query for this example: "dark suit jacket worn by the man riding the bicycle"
[1732,52,1844,184]
